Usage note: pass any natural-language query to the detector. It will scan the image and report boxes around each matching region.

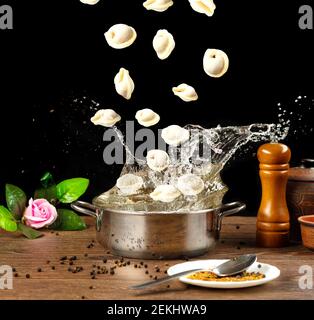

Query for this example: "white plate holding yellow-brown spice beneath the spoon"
[167,260,280,289]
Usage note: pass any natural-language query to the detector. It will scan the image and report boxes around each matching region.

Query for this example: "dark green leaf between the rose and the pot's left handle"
[49,209,86,231]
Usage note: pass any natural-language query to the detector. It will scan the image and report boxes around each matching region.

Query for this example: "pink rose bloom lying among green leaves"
[23,198,58,229]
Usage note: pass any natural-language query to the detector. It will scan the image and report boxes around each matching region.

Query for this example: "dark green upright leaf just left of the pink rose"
[5,184,27,219]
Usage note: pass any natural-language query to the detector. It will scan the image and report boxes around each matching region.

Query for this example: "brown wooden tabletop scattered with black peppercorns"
[0,217,314,300]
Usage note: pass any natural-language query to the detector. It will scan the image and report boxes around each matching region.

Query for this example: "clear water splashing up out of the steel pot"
[95,123,289,212]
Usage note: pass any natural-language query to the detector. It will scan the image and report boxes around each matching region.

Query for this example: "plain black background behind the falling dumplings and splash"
[0,0,314,214]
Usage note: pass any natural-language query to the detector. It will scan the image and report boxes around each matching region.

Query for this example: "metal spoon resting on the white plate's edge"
[130,254,257,289]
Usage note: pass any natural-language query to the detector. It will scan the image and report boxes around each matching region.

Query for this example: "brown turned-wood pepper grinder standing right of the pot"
[256,143,291,248]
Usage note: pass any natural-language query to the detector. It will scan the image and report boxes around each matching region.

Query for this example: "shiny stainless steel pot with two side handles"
[71,201,245,259]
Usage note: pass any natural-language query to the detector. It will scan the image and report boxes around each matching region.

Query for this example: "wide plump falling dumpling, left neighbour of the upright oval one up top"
[105,23,137,49]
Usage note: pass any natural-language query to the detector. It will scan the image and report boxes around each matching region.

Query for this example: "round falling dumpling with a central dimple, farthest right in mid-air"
[203,49,229,78]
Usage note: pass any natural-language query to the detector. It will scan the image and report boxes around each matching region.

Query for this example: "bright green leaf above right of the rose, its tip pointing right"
[57,178,89,203]
